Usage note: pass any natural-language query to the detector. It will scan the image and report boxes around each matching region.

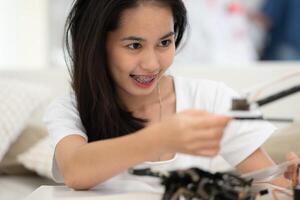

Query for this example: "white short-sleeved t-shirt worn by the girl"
[44,77,275,192]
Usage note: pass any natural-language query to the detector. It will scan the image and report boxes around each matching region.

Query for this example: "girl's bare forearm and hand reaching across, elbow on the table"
[55,111,230,190]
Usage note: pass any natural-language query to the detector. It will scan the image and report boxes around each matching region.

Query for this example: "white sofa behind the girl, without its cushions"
[0,63,300,200]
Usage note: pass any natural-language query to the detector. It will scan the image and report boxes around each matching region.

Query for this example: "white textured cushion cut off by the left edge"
[0,78,49,161]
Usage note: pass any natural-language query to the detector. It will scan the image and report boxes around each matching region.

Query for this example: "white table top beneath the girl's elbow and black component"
[24,186,292,200]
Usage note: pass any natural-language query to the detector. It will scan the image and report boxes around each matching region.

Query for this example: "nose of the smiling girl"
[141,49,159,72]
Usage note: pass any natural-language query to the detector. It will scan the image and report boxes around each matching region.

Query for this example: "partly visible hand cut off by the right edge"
[284,152,300,186]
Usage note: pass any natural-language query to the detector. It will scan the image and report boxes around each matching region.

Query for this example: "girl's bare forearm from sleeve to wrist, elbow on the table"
[55,123,164,190]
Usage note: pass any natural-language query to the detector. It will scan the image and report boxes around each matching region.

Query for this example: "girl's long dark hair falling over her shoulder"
[65,0,187,142]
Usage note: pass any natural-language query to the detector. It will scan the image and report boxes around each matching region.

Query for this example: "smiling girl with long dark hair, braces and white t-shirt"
[45,0,296,191]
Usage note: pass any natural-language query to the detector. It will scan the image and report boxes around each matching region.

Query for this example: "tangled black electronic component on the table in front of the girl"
[130,168,257,200]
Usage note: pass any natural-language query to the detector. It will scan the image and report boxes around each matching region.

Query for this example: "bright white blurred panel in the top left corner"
[0,0,49,69]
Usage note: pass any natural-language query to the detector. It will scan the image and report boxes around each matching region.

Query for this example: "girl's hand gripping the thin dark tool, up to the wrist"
[158,110,231,157]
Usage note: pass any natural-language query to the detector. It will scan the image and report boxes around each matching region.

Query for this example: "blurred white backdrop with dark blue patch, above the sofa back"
[0,0,300,69]
